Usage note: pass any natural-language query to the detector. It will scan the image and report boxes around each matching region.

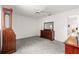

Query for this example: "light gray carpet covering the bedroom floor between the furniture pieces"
[14,37,65,54]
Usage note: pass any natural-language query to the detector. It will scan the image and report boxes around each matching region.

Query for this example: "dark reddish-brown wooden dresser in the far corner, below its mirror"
[40,29,54,41]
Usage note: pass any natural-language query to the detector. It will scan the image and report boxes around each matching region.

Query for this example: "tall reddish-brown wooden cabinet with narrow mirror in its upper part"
[2,8,16,54]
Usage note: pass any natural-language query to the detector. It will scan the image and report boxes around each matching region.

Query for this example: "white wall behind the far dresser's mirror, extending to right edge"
[40,9,79,42]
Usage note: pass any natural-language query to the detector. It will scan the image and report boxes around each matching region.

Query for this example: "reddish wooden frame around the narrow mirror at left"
[2,8,13,29]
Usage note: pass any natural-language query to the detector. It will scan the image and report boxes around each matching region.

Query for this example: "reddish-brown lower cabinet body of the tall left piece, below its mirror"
[2,28,16,53]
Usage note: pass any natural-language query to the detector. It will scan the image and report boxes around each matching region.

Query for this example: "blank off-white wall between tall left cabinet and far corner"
[12,14,40,39]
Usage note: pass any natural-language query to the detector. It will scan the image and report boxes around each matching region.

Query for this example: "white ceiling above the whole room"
[2,5,79,18]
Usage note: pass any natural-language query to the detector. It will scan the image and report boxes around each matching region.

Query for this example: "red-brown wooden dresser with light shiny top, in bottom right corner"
[65,36,79,54]
